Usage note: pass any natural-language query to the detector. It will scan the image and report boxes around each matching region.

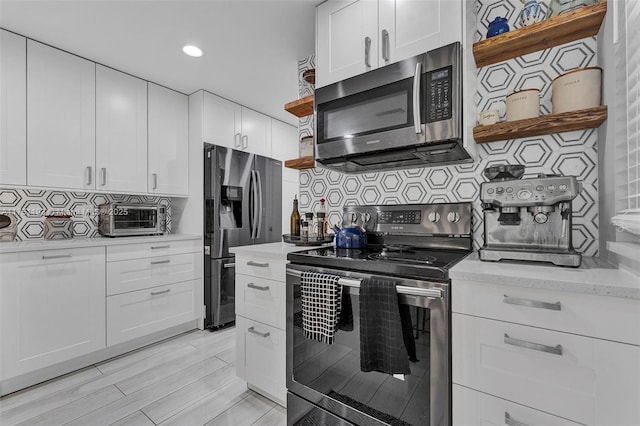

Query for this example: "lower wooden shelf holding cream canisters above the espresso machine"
[473,105,607,143]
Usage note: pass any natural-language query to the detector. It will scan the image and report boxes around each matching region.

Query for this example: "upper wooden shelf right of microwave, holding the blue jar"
[473,0,607,67]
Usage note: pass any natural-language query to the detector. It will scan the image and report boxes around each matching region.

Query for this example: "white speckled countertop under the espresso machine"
[449,253,640,299]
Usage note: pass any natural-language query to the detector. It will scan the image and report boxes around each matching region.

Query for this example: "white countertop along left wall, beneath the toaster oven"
[0,234,202,254]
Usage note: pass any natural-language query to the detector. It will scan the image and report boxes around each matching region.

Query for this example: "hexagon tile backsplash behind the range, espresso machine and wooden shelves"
[299,0,598,256]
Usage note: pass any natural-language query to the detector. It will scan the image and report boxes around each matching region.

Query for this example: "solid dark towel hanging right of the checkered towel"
[360,278,411,374]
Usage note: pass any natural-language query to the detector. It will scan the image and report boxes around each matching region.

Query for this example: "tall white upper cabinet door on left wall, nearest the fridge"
[148,83,189,195]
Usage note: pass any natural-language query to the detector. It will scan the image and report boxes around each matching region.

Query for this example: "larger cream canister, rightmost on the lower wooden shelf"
[551,67,602,114]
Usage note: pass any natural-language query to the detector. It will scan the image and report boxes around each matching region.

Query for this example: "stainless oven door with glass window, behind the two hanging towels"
[287,264,451,426]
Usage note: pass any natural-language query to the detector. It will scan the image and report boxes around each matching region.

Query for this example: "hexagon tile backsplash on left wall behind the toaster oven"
[0,188,171,241]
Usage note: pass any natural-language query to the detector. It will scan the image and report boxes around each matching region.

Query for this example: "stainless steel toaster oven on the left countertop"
[98,202,167,237]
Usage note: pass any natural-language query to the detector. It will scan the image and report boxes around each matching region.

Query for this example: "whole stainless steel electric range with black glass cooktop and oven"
[287,203,472,426]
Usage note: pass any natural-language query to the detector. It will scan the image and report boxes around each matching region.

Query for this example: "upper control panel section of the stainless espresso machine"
[480,176,580,207]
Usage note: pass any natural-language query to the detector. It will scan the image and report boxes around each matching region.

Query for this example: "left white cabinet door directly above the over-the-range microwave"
[316,0,378,87]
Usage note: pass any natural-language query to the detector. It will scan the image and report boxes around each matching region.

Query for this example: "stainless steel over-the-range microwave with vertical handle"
[314,43,471,173]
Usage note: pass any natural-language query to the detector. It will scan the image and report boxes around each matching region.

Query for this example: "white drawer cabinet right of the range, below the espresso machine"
[451,280,640,426]
